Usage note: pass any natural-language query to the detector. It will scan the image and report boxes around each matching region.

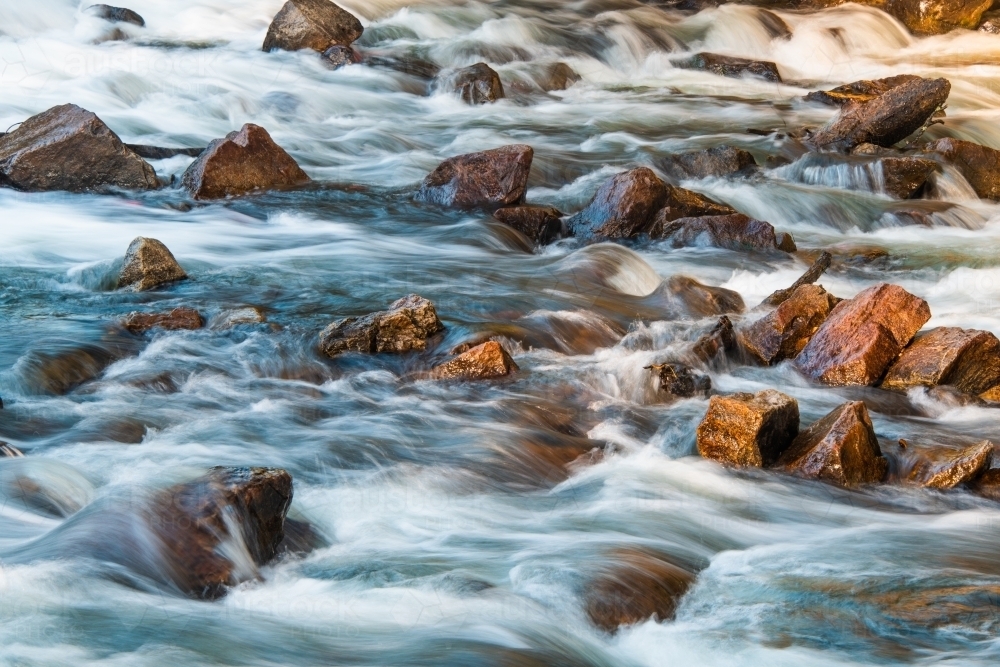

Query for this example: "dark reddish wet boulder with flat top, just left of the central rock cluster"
[417,144,535,209]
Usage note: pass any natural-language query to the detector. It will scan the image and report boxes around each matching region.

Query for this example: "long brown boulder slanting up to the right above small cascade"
[810,79,951,150]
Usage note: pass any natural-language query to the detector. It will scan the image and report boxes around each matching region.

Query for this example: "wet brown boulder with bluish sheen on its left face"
[567,167,667,239]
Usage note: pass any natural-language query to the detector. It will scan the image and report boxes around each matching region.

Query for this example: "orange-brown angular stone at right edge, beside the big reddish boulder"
[882,327,1000,394]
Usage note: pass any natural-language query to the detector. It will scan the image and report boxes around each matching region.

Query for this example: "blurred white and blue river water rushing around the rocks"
[0,0,1000,666]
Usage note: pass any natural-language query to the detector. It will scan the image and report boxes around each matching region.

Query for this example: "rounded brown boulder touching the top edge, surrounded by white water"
[263,0,365,53]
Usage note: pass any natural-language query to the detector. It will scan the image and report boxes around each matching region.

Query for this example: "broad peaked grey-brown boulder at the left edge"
[0,104,159,192]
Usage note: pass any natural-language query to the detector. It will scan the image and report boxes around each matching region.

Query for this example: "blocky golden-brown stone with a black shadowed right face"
[697,389,799,468]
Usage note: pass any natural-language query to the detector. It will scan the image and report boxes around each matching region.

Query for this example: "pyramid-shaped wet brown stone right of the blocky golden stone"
[778,401,888,486]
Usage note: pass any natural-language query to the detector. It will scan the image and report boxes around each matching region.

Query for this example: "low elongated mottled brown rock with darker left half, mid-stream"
[319,294,444,357]
